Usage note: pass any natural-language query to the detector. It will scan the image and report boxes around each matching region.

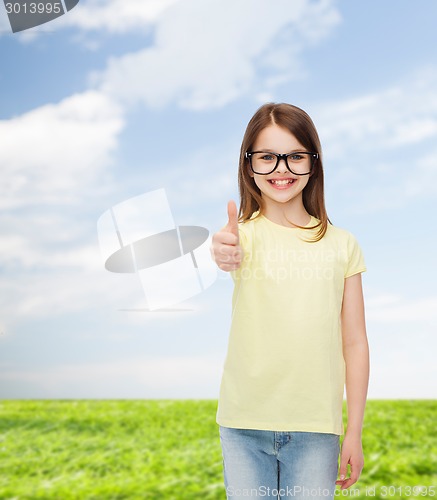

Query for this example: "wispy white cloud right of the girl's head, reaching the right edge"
[314,68,437,157]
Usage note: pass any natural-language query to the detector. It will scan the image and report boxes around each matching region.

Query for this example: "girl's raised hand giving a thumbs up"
[211,201,243,271]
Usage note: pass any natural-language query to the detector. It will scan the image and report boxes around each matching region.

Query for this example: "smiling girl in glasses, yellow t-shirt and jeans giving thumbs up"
[211,104,369,499]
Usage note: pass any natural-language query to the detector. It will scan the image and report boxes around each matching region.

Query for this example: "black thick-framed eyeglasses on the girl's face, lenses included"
[245,151,319,175]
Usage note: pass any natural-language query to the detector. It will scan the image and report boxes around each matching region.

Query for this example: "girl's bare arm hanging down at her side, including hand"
[337,273,369,489]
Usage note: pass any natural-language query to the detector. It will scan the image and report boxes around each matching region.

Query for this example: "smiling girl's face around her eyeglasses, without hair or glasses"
[249,124,310,208]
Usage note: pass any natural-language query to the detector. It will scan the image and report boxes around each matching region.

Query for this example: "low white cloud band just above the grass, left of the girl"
[0,356,223,399]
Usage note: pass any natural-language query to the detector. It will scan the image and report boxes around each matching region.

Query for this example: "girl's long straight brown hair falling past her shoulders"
[238,103,332,242]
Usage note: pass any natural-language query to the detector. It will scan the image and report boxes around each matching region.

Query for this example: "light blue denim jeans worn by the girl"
[219,426,340,500]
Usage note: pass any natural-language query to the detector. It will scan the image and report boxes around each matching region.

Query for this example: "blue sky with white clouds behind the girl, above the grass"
[0,0,437,398]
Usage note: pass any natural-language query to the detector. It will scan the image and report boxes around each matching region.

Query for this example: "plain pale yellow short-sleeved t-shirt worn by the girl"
[216,213,366,435]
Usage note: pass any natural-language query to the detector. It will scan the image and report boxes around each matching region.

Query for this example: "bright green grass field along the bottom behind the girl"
[0,400,437,500]
